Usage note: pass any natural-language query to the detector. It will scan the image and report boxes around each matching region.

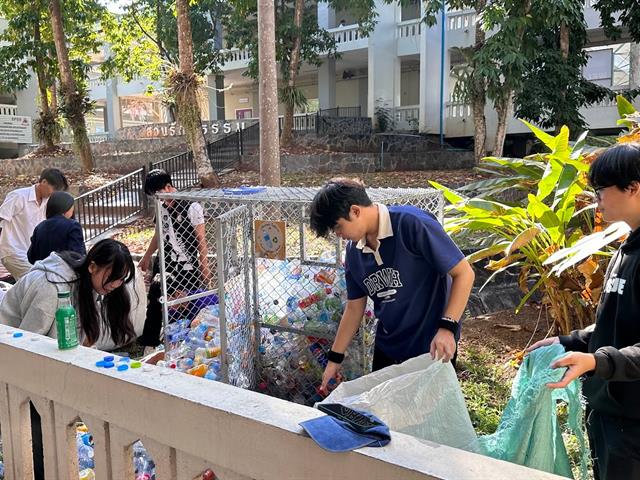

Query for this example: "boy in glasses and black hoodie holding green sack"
[529,144,640,480]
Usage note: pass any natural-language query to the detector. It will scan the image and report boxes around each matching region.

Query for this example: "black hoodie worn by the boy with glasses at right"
[560,228,640,419]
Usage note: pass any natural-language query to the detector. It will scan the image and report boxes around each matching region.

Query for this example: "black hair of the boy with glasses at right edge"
[589,143,640,190]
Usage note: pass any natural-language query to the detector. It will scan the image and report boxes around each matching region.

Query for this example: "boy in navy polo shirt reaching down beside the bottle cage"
[310,178,474,392]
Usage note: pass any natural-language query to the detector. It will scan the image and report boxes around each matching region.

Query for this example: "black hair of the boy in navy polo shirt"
[310,178,372,237]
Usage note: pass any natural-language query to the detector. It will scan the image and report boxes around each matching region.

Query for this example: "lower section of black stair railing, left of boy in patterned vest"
[74,167,147,241]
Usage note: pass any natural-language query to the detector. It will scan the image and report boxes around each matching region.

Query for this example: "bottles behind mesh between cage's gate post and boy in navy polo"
[258,260,373,405]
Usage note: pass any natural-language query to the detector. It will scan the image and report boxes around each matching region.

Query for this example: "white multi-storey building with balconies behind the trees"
[5,0,640,156]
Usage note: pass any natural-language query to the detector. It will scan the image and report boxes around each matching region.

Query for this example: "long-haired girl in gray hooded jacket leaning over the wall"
[0,239,138,347]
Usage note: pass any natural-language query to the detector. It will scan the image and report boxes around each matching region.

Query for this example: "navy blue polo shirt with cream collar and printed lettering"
[345,204,464,361]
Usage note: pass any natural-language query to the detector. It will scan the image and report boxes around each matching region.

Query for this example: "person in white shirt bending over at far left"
[0,168,69,280]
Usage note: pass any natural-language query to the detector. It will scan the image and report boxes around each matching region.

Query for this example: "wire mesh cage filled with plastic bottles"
[156,187,444,404]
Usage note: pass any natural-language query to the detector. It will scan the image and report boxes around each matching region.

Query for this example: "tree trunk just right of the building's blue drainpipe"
[470,0,487,164]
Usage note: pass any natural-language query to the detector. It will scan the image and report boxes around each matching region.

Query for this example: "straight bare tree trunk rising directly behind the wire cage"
[258,0,280,187]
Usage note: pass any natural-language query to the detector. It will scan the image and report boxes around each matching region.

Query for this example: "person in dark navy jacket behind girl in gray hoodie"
[27,192,87,264]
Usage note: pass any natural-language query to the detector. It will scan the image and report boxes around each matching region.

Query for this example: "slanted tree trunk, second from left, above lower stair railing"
[49,0,94,172]
